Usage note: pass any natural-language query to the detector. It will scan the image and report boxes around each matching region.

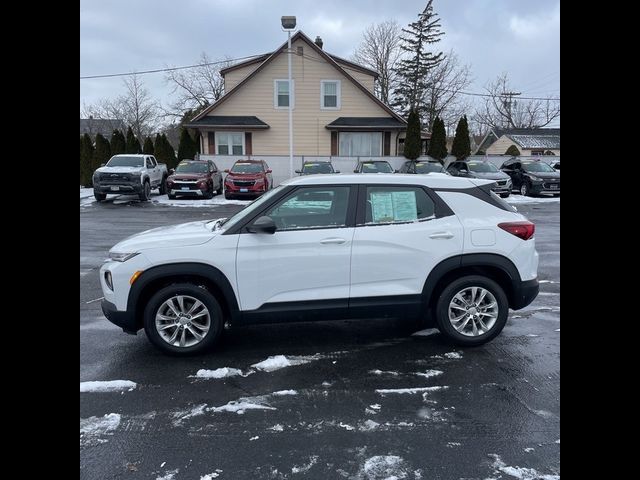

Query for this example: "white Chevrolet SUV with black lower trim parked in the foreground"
[100,173,538,354]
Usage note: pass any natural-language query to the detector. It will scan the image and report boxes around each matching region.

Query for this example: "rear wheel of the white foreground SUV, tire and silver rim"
[435,275,509,346]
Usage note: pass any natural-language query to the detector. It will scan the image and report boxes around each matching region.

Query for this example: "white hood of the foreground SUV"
[111,220,219,252]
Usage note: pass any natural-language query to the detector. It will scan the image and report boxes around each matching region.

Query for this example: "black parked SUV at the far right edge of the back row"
[502,157,560,197]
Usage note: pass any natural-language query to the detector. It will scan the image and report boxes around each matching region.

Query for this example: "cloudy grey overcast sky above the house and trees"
[80,0,560,126]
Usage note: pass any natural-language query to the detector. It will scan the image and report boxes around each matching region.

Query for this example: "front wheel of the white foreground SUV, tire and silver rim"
[144,283,224,355]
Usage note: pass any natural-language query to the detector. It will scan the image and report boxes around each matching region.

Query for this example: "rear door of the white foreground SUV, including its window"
[350,185,463,307]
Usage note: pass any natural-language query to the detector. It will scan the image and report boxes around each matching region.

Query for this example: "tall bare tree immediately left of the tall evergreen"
[352,20,402,104]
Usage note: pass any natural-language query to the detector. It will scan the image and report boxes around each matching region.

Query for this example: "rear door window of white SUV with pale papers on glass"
[365,186,435,225]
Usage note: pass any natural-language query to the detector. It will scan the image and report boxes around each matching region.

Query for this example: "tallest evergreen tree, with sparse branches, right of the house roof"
[393,0,444,117]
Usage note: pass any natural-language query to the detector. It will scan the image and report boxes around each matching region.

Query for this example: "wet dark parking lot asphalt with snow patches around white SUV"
[80,193,560,480]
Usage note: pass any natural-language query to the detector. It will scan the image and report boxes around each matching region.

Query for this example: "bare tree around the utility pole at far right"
[474,73,560,128]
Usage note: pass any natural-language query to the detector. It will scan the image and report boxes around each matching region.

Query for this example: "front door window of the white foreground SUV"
[265,186,351,231]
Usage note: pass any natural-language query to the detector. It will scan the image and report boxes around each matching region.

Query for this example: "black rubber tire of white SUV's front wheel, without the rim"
[143,283,224,356]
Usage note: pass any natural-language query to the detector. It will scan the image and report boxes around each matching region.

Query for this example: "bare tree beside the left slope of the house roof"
[165,52,232,117]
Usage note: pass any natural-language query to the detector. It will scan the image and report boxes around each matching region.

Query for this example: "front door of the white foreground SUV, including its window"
[236,185,355,311]
